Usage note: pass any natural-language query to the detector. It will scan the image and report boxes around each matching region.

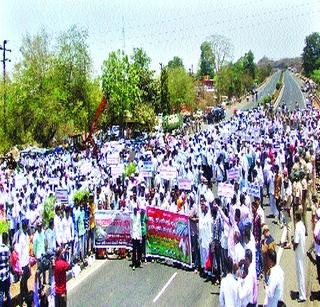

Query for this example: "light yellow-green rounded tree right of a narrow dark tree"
[168,67,195,113]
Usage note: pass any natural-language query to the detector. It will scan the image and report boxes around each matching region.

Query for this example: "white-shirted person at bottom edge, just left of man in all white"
[264,250,284,307]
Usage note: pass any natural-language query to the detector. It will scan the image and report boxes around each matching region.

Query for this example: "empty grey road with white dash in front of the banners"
[68,260,218,307]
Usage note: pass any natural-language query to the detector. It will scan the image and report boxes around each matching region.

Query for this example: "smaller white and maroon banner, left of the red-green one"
[94,210,132,249]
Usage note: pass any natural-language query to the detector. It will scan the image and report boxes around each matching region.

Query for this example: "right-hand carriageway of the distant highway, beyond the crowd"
[279,70,306,111]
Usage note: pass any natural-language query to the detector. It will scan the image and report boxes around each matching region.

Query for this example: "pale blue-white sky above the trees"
[0,0,320,74]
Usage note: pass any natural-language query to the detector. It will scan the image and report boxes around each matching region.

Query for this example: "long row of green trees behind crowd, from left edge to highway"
[0,26,271,152]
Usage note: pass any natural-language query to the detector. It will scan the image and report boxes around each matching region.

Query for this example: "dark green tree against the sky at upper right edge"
[302,32,320,76]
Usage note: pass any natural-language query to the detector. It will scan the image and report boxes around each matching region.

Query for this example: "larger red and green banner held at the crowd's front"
[146,207,192,267]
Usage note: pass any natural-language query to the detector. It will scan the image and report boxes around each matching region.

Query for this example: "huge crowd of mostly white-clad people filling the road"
[0,97,320,306]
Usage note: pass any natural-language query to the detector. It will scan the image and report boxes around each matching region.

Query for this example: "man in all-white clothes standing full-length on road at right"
[293,213,306,302]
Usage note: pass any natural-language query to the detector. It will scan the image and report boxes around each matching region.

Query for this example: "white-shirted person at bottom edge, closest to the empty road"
[219,258,240,307]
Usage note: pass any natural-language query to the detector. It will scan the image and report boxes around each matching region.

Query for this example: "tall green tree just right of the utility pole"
[12,31,62,146]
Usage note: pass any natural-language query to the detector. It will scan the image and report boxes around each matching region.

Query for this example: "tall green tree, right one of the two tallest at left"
[52,26,99,131]
